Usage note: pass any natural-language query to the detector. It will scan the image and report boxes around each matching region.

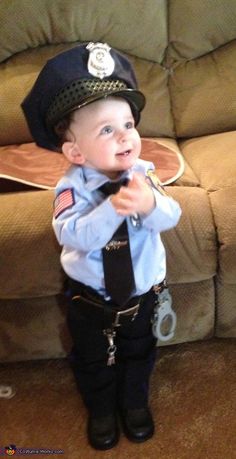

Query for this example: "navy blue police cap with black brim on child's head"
[21,43,145,151]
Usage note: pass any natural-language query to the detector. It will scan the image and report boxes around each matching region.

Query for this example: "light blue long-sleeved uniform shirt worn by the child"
[53,159,181,298]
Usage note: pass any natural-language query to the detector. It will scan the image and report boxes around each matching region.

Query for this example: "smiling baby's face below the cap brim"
[62,97,141,178]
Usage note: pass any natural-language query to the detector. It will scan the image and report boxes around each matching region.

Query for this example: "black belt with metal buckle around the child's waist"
[69,279,165,328]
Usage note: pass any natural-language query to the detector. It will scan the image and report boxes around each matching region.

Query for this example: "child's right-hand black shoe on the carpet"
[121,408,154,443]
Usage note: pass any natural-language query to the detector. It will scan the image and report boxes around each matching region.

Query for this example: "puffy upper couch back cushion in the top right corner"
[168,0,236,62]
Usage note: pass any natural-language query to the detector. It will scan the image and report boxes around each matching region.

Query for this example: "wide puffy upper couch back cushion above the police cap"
[0,0,168,63]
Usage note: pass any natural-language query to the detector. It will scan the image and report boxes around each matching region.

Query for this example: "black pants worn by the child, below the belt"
[68,284,156,416]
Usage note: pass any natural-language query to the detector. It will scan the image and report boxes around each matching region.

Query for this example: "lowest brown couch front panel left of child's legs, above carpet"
[0,295,71,362]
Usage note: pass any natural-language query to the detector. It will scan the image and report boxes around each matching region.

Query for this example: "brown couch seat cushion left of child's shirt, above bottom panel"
[0,190,64,298]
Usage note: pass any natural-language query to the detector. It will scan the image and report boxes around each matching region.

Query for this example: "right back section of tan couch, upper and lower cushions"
[166,0,236,138]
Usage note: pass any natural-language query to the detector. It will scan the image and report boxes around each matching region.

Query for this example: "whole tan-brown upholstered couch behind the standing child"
[0,0,236,361]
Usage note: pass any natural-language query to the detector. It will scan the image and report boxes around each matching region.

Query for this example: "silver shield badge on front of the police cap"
[86,42,115,79]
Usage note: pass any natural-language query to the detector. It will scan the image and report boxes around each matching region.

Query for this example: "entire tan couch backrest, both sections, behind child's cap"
[0,0,236,145]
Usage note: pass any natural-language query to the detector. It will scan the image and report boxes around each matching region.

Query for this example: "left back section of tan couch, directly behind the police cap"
[0,0,174,145]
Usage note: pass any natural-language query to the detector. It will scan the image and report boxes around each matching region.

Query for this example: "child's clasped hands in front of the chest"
[111,173,155,217]
